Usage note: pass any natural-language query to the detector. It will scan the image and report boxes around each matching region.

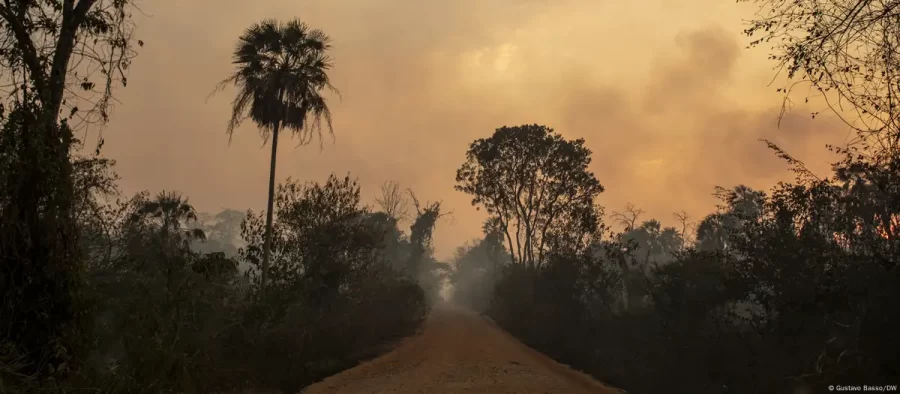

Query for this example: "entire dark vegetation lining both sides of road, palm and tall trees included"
[0,0,900,393]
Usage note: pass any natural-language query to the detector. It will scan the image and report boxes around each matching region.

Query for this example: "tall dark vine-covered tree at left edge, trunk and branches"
[0,0,141,380]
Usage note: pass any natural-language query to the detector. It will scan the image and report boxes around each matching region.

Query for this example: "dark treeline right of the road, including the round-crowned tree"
[453,125,900,393]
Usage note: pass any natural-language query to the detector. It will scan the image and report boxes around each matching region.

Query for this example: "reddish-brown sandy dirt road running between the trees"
[304,304,617,394]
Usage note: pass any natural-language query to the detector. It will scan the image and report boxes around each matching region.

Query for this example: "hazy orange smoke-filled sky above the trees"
[98,0,846,257]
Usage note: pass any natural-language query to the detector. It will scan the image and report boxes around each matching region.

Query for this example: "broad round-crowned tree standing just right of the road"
[456,125,603,269]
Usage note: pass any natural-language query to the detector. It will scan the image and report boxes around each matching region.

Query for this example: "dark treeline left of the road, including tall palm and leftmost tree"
[0,5,447,393]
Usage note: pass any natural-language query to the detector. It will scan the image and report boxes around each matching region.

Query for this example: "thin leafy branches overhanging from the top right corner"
[738,0,900,150]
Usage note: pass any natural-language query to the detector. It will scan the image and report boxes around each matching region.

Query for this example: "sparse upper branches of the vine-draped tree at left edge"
[0,0,143,128]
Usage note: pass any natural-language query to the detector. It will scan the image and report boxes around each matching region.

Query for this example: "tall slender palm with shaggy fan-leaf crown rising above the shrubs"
[217,19,337,291]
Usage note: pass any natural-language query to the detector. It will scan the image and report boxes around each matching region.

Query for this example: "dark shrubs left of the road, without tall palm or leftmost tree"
[0,149,442,393]
